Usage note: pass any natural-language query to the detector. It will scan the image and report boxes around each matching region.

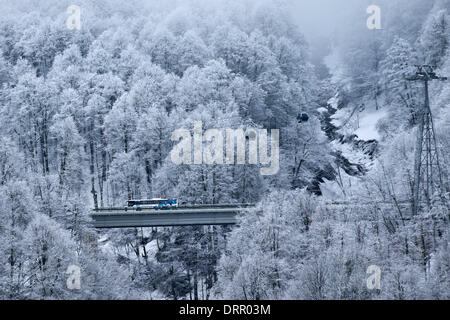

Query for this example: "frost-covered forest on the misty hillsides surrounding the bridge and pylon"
[0,0,450,300]
